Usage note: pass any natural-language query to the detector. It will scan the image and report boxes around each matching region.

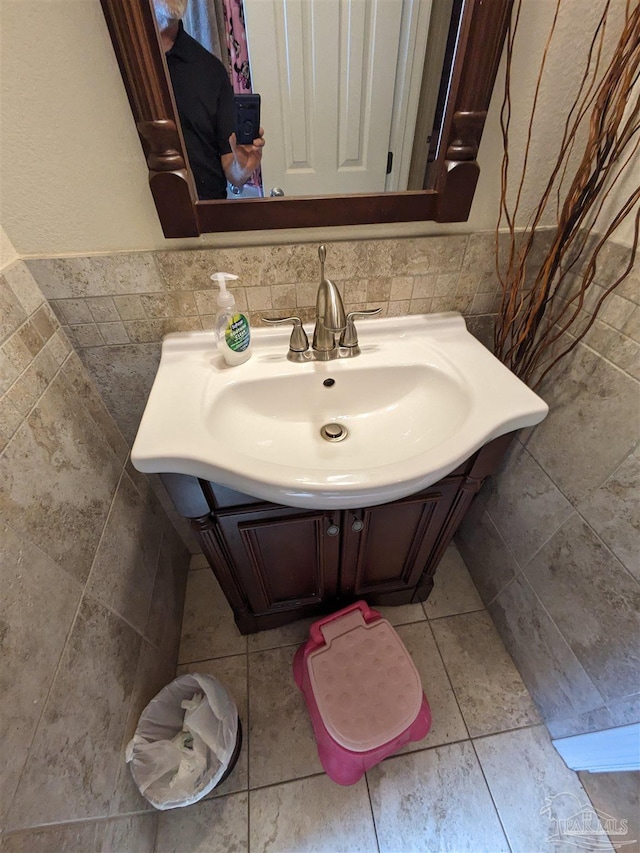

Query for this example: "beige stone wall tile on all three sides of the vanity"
[0,226,640,850]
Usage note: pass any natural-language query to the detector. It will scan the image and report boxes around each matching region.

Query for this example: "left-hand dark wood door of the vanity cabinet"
[217,506,340,616]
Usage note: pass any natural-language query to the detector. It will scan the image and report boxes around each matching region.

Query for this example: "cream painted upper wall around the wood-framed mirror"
[0,0,625,257]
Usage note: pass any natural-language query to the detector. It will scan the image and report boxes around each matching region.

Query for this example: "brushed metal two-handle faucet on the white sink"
[262,246,382,362]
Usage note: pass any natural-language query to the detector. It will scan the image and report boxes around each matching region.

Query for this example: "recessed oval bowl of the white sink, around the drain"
[205,359,470,474]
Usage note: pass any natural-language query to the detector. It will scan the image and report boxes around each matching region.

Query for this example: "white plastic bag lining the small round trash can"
[125,673,238,810]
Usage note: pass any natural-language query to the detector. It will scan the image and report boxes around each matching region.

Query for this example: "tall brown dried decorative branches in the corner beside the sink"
[494,0,640,388]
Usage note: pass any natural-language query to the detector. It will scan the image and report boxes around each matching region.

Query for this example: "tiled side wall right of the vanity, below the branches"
[457,238,640,737]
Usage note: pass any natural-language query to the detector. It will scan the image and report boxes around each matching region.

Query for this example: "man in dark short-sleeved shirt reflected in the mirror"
[153,0,264,199]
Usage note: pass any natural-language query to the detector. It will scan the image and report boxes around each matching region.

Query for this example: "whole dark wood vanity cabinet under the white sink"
[192,435,511,633]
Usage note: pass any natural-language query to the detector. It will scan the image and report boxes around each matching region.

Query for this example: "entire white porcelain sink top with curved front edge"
[131,314,548,509]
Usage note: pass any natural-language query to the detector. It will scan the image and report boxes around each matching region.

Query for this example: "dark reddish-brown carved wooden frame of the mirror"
[101,0,513,237]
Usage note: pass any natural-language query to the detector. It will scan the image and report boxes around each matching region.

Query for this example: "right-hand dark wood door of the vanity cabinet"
[340,478,459,604]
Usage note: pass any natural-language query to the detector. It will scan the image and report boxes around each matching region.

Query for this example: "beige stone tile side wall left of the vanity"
[0,261,189,851]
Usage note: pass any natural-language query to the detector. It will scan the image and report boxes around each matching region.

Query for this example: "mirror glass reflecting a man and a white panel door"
[153,0,461,199]
